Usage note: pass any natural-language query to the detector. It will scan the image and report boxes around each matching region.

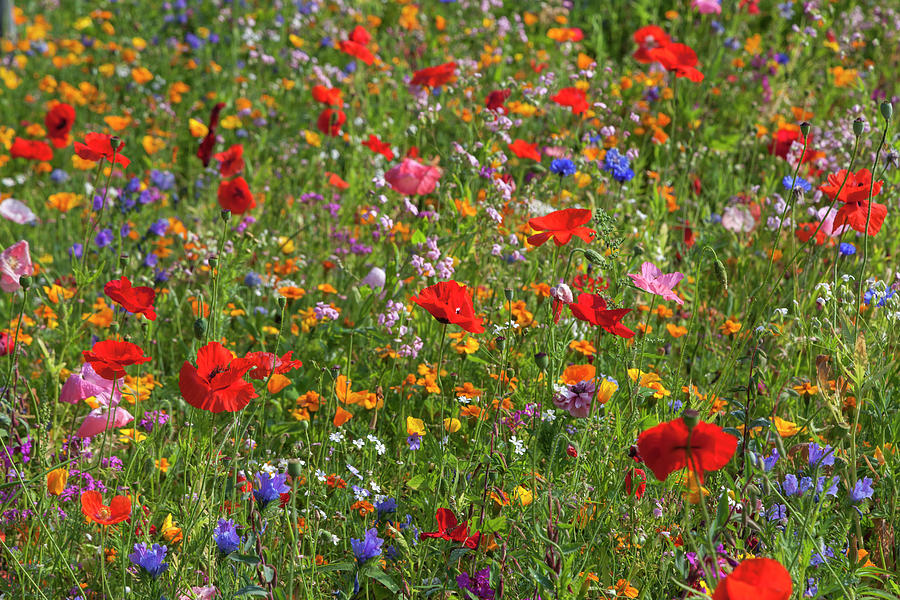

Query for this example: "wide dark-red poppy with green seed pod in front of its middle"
[637,418,737,484]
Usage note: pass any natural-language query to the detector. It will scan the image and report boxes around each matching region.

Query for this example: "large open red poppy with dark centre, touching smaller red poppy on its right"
[178,342,257,413]
